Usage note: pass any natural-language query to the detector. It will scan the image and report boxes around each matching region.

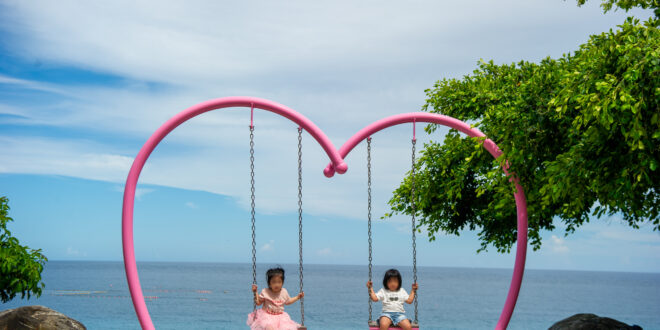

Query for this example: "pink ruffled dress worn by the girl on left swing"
[247,288,299,330]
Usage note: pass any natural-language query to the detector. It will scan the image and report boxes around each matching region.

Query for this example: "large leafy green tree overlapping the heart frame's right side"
[385,0,660,252]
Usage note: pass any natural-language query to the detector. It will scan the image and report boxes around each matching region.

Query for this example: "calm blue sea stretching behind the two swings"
[0,261,660,329]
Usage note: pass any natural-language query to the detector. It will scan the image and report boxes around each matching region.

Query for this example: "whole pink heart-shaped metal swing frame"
[122,97,527,329]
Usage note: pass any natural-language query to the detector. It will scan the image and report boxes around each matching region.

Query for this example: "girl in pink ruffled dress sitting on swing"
[247,267,305,330]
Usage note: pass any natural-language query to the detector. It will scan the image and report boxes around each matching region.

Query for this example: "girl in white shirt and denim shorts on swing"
[367,269,418,330]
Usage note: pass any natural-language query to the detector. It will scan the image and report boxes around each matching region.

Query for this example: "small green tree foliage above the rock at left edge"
[0,197,48,303]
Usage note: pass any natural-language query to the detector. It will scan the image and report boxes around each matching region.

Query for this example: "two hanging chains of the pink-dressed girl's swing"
[250,112,307,330]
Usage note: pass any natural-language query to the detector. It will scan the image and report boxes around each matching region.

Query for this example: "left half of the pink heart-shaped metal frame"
[122,96,348,329]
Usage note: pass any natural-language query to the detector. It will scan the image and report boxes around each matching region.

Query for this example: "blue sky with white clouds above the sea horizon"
[0,0,660,272]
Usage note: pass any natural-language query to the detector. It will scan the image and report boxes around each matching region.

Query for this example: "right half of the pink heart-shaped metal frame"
[323,112,527,329]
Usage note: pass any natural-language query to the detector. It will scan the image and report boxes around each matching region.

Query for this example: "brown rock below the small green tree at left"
[0,306,87,330]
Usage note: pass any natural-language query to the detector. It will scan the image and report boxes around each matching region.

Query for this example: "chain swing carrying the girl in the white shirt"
[367,134,419,330]
